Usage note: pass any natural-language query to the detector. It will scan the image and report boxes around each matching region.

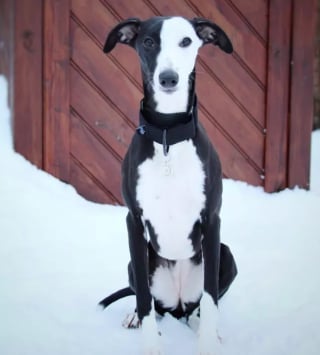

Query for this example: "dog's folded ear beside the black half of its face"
[103,18,141,53]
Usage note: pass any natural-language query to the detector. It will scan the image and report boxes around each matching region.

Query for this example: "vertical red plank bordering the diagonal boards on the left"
[44,0,70,181]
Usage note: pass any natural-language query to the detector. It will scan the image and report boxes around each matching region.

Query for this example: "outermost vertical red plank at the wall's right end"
[288,0,316,188]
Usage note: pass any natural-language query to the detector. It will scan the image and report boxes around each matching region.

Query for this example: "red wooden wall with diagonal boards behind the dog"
[5,0,315,203]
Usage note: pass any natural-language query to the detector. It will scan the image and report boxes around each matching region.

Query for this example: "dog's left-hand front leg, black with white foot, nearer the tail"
[127,212,162,355]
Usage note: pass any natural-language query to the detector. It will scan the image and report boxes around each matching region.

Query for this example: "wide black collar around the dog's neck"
[137,96,198,155]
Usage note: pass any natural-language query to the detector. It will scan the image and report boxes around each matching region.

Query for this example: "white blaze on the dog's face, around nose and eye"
[153,17,202,113]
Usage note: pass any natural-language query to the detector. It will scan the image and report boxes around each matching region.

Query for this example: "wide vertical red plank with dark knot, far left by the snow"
[14,0,43,168]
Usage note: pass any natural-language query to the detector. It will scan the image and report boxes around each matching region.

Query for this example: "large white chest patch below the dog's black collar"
[136,140,205,260]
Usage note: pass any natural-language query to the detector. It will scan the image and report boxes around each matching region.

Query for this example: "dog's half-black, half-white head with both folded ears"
[104,17,233,113]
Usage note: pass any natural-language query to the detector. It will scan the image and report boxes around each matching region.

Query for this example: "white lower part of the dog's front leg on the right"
[198,292,220,355]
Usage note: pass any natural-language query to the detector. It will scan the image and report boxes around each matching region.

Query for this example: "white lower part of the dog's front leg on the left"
[141,308,163,355]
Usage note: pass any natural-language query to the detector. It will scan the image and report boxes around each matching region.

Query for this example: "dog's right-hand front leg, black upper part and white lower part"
[198,215,220,355]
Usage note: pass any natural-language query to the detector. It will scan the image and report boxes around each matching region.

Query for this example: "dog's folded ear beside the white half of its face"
[192,18,233,53]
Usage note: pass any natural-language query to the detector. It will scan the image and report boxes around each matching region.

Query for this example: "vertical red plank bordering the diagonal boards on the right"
[264,0,292,192]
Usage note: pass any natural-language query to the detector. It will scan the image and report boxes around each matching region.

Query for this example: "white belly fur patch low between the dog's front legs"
[150,259,203,309]
